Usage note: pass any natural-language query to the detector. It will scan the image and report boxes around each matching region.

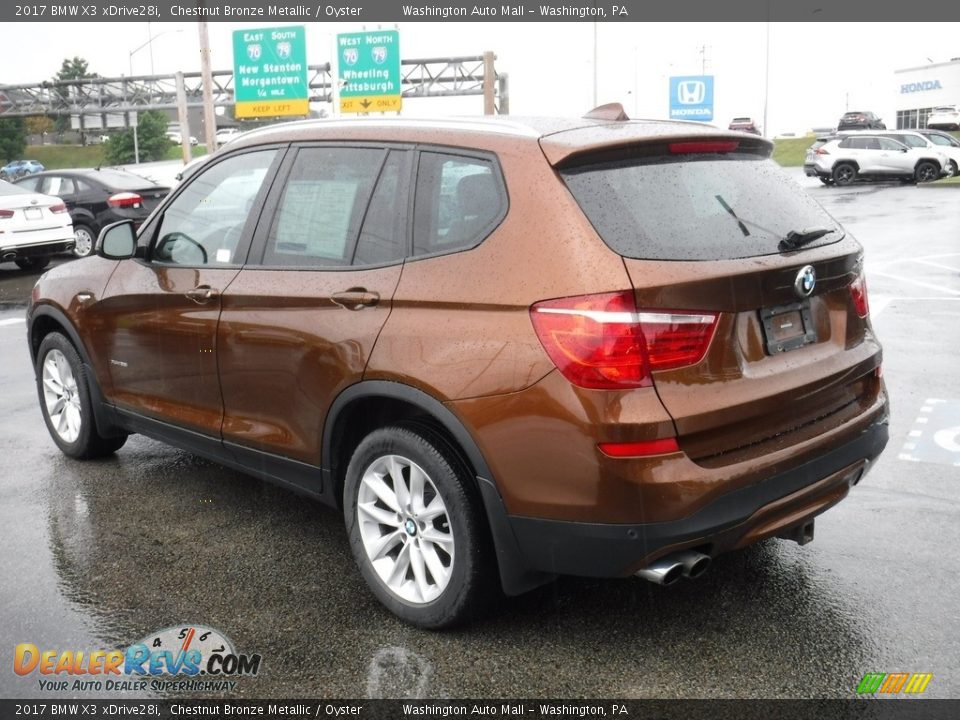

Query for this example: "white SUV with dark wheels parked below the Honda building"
[803,132,950,185]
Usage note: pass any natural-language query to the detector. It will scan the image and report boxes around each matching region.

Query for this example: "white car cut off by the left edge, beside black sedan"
[0,180,74,270]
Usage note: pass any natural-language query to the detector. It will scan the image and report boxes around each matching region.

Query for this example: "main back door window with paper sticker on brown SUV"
[263,148,385,267]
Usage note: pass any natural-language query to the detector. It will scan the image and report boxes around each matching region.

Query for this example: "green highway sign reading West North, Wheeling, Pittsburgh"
[337,30,402,112]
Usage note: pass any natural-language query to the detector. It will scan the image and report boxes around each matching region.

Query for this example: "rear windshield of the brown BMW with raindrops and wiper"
[561,153,843,260]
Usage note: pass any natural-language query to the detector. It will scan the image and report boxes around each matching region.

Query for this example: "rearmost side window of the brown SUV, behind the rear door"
[413,152,506,255]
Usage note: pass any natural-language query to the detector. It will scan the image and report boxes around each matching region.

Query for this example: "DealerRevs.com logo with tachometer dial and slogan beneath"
[13,625,261,692]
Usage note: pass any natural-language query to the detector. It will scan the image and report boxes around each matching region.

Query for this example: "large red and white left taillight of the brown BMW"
[530,292,718,390]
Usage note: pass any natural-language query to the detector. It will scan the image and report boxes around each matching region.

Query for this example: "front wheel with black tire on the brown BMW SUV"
[36,332,127,460]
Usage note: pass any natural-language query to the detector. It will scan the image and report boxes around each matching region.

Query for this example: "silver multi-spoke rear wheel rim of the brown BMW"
[357,455,454,605]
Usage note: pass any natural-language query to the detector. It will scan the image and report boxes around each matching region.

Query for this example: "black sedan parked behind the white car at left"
[16,168,170,257]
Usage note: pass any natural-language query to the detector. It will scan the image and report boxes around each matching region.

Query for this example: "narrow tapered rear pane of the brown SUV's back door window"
[353,152,406,265]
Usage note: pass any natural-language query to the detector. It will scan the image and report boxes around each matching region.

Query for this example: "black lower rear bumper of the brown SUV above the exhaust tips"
[509,416,888,577]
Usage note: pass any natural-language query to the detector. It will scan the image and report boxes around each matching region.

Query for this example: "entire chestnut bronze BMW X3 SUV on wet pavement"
[28,108,887,628]
